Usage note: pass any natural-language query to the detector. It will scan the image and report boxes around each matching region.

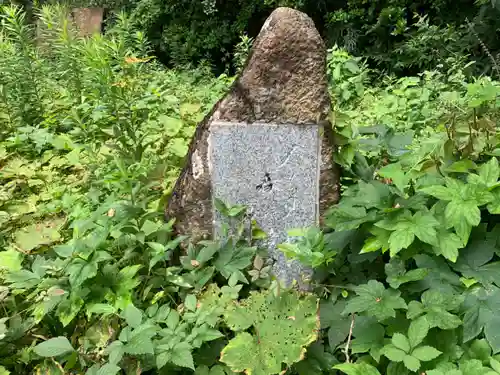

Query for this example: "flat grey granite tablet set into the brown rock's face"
[209,122,321,284]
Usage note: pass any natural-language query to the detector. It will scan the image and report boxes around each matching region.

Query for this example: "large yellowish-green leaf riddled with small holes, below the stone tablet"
[220,291,319,375]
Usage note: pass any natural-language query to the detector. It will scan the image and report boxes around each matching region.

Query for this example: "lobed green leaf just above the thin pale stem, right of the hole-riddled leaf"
[344,280,407,321]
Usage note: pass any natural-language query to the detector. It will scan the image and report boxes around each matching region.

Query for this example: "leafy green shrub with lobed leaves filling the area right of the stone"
[284,48,500,375]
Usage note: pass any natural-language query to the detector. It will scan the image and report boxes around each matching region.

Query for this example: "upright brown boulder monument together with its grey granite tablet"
[166,8,339,283]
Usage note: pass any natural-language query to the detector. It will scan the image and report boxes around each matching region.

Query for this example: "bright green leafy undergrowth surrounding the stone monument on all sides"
[0,1,500,375]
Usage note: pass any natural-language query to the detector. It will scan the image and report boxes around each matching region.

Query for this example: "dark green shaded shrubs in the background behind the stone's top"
[102,0,500,76]
